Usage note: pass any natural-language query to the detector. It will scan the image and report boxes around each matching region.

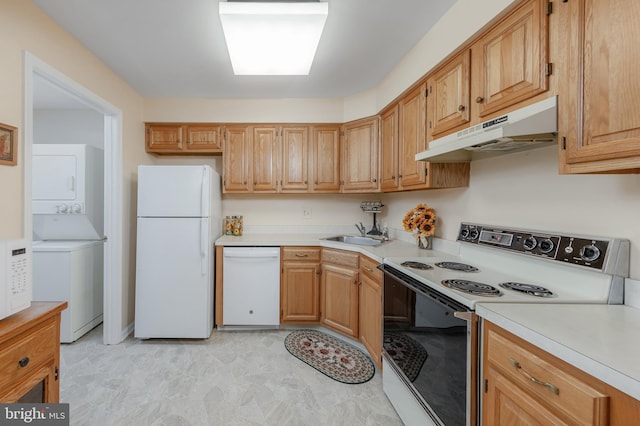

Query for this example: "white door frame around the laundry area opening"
[23,51,125,344]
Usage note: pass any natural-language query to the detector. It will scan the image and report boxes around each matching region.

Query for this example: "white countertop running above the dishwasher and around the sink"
[216,233,442,262]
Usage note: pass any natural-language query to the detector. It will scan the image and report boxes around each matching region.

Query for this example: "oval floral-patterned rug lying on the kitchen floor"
[284,330,375,384]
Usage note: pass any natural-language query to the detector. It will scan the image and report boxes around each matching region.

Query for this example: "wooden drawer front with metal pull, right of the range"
[487,328,609,424]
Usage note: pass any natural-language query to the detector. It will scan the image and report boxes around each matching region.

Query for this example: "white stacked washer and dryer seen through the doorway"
[32,144,104,343]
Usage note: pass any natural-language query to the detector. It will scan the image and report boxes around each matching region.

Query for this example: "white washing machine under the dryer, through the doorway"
[32,240,104,343]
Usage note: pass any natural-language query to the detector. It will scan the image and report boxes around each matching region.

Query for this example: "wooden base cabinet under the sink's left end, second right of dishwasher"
[320,248,359,339]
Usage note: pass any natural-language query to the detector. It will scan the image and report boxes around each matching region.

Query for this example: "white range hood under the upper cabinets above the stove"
[415,96,558,162]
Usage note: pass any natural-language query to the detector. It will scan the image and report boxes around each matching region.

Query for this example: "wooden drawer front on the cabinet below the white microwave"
[0,323,58,388]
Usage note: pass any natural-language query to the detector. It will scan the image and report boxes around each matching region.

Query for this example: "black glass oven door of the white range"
[380,265,477,426]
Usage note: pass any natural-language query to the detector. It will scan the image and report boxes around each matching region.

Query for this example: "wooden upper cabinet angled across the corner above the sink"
[341,116,380,192]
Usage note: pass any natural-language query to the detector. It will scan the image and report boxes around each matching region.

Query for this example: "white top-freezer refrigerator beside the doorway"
[134,166,222,339]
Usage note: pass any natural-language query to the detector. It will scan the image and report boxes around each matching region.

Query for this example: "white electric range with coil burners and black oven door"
[380,223,629,426]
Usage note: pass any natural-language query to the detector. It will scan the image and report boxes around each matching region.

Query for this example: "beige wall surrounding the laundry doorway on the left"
[0,0,152,328]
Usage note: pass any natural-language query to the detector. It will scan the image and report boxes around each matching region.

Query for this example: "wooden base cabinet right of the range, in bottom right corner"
[482,321,640,425]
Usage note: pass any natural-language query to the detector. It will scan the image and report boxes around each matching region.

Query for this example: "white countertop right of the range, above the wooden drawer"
[476,303,640,399]
